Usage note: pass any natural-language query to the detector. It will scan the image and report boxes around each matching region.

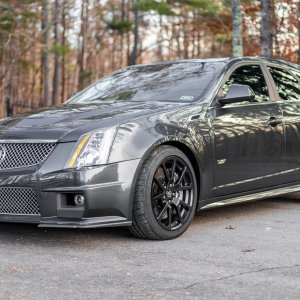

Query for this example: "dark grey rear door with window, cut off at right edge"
[267,64,300,183]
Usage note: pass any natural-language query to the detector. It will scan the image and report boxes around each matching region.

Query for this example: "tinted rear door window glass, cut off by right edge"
[268,67,300,101]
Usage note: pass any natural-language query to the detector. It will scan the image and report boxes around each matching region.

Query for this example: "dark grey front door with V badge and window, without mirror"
[210,63,284,196]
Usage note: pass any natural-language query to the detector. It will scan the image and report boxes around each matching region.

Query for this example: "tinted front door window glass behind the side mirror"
[218,65,270,103]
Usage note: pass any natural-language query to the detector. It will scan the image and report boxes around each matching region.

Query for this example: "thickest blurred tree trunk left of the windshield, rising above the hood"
[42,0,51,106]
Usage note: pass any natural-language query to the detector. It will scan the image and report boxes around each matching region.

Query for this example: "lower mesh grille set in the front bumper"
[0,187,40,215]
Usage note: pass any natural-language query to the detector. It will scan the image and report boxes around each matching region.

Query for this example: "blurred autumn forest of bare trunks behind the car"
[0,0,300,118]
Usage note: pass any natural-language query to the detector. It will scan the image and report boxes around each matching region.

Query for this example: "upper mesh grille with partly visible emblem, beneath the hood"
[0,142,56,170]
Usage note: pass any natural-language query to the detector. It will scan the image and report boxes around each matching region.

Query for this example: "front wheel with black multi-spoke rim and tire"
[129,146,197,240]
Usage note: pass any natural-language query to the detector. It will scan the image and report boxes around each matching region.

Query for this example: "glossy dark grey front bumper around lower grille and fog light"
[0,151,140,228]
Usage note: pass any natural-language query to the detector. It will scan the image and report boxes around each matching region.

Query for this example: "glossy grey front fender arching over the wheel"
[109,111,213,214]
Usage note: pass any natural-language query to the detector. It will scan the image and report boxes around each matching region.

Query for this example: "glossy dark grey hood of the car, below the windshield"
[0,102,186,142]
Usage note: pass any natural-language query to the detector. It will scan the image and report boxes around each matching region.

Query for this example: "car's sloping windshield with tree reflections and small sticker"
[67,61,224,104]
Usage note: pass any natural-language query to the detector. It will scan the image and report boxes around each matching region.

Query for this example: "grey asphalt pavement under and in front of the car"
[0,199,300,299]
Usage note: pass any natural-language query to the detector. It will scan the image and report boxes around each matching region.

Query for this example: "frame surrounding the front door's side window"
[209,61,276,108]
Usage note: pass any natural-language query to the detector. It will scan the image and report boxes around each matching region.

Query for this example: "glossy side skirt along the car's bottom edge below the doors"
[201,184,300,210]
